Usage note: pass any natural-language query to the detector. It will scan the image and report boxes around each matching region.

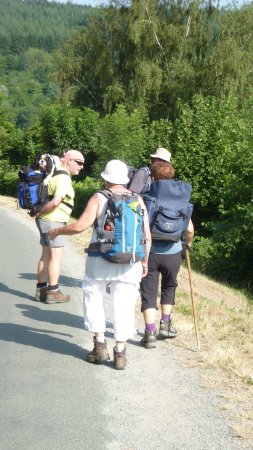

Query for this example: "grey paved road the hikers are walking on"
[0,207,250,450]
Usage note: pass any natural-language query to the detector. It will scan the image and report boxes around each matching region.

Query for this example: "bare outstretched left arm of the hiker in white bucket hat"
[48,194,99,239]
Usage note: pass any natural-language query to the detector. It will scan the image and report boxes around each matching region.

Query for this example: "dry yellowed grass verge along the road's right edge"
[173,266,253,446]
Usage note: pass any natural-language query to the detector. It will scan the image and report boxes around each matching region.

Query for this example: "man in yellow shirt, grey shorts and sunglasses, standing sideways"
[33,149,84,303]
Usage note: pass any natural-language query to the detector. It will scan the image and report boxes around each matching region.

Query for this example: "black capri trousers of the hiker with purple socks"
[140,252,182,312]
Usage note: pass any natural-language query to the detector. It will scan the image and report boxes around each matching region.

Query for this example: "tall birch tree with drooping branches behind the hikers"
[56,0,253,120]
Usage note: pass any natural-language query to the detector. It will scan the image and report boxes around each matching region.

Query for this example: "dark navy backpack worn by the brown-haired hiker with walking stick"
[143,179,193,242]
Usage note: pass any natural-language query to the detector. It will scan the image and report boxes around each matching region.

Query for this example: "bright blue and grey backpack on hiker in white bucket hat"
[88,190,146,264]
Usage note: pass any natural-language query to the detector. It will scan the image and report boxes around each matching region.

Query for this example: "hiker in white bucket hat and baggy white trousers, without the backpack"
[49,159,151,369]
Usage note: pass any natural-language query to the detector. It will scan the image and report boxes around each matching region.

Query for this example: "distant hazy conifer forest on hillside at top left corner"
[0,0,91,55]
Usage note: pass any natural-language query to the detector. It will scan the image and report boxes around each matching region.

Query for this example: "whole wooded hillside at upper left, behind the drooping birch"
[0,0,92,129]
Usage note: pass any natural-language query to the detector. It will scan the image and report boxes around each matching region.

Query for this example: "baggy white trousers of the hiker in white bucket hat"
[83,280,139,342]
